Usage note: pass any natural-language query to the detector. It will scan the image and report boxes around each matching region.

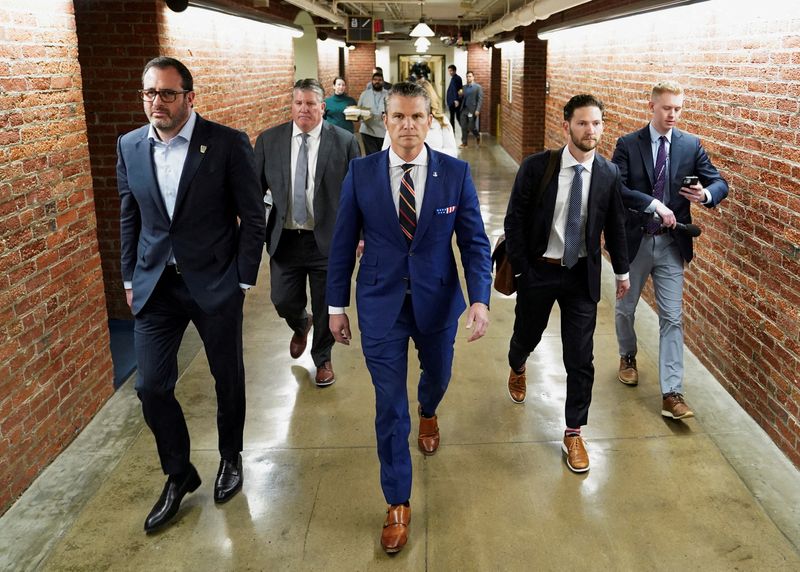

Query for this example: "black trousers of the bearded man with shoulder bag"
[508,258,597,428]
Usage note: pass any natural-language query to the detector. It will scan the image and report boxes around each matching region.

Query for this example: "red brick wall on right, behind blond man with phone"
[546,2,800,466]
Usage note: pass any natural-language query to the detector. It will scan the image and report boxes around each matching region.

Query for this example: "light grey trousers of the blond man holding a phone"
[615,233,683,394]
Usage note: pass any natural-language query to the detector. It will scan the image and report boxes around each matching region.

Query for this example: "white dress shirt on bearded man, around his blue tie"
[543,146,594,258]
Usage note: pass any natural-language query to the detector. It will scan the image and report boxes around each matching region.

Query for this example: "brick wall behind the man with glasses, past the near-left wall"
[75,0,294,319]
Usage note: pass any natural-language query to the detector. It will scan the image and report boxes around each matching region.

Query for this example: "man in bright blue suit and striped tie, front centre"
[327,83,491,553]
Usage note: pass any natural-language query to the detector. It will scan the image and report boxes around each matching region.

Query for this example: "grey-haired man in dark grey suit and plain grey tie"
[255,79,360,387]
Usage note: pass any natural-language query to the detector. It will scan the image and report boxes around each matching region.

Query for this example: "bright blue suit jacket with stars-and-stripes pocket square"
[327,147,492,339]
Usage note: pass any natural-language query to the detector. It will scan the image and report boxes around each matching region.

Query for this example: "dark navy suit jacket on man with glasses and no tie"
[117,115,266,314]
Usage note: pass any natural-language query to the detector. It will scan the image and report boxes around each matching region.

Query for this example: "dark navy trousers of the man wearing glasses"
[134,266,245,475]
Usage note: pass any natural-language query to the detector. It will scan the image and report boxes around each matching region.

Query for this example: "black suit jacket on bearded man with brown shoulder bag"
[504,148,628,302]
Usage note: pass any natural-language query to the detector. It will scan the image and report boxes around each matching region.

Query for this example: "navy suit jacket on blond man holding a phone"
[612,125,728,262]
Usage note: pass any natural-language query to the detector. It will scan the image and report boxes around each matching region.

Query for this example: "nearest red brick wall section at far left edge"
[0,0,113,514]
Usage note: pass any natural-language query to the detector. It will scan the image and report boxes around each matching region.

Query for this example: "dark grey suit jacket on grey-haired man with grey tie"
[255,121,361,256]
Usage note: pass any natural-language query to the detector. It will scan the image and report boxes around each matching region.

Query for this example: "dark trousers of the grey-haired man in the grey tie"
[269,229,335,367]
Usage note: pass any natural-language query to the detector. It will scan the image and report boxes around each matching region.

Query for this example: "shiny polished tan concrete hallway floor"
[0,138,800,571]
